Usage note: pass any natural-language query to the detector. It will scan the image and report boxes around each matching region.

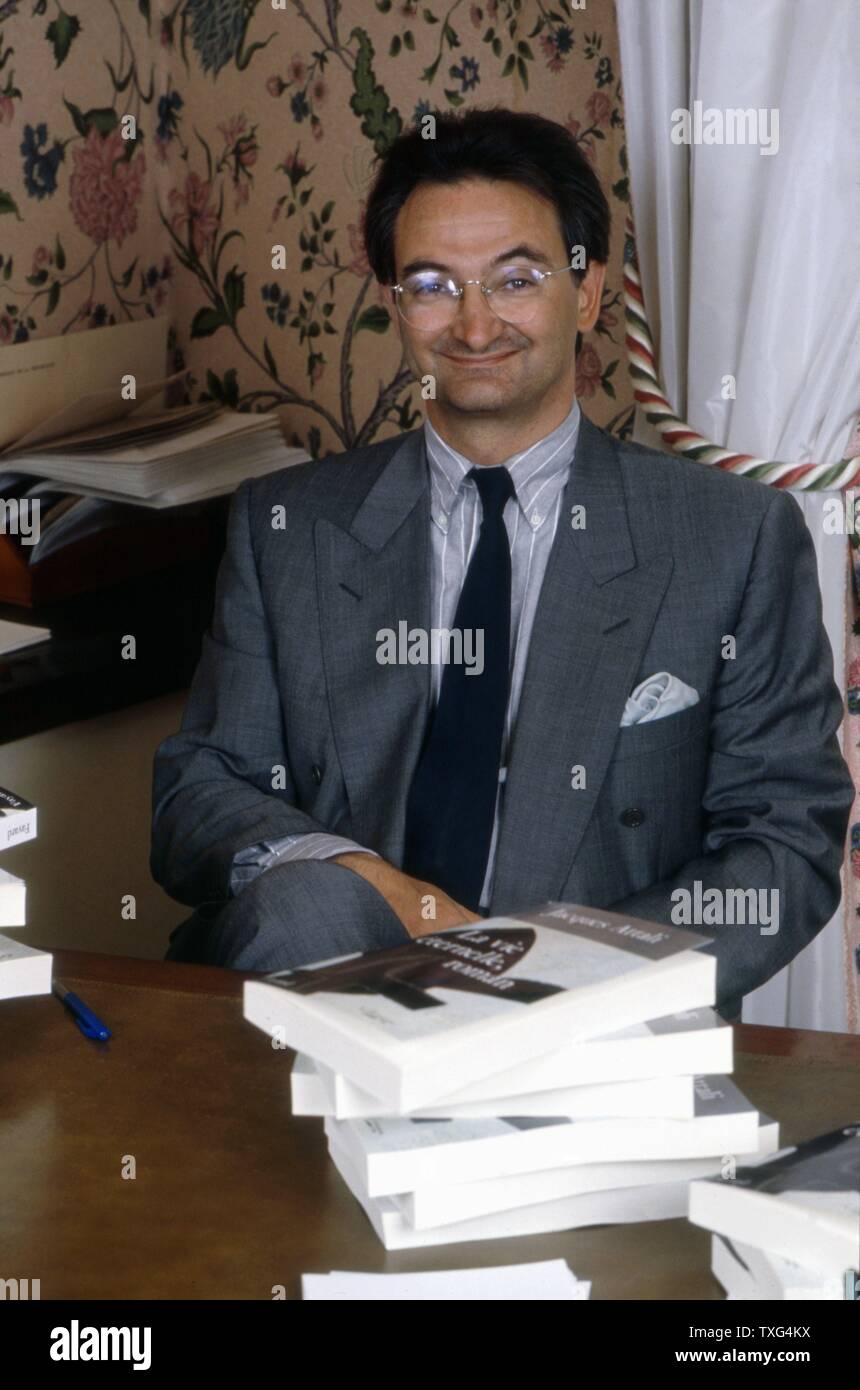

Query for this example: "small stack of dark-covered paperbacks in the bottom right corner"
[689,1123,860,1300]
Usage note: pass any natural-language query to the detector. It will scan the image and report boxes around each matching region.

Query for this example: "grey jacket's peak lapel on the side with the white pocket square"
[490,416,672,912]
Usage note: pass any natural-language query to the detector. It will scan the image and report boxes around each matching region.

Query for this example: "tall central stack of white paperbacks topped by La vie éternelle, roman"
[245,904,778,1250]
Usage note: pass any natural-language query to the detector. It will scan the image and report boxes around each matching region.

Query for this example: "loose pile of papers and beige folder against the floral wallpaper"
[0,321,307,514]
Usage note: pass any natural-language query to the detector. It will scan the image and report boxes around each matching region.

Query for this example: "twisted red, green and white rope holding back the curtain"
[624,213,860,492]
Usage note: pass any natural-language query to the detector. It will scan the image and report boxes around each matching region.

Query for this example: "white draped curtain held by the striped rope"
[617,0,860,1031]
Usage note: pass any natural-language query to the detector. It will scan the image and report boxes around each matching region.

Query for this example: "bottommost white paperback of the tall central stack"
[329,1140,697,1250]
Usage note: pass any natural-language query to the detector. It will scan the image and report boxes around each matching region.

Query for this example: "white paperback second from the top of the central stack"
[296,1008,734,1120]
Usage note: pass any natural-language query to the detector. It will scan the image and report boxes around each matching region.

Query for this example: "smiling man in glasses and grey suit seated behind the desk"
[151,110,853,1015]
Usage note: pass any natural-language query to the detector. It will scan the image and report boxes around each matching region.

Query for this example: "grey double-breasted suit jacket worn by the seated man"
[151,417,853,1006]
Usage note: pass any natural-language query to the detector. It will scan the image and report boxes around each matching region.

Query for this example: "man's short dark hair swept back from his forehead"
[364,107,610,285]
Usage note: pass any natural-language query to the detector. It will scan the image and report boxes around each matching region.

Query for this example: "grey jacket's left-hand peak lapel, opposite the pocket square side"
[314,430,431,862]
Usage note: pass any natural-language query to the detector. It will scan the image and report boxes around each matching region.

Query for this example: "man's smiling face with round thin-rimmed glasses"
[395,179,603,420]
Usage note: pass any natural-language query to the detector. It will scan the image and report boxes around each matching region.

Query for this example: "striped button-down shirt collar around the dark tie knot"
[424,399,581,531]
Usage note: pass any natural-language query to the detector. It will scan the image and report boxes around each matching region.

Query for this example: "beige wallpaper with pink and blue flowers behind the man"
[0,0,632,455]
